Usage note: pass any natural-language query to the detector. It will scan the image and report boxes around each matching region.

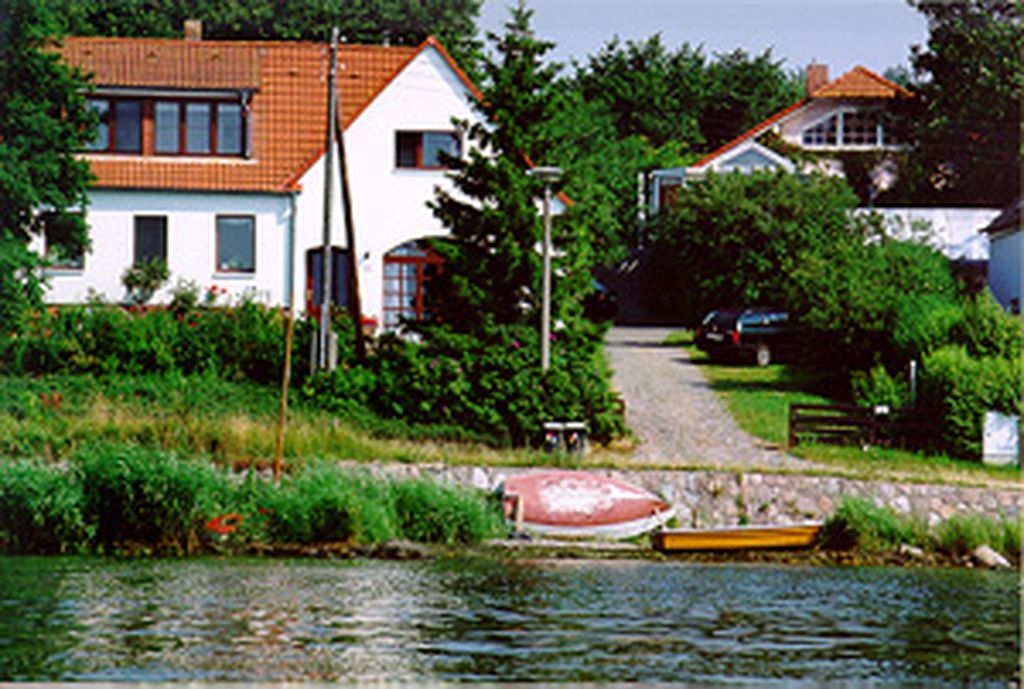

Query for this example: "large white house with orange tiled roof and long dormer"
[38,28,495,327]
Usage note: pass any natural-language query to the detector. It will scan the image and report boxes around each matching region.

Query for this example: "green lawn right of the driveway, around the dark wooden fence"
[666,332,1020,483]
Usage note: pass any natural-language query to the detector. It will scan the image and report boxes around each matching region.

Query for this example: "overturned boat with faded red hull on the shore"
[499,470,675,539]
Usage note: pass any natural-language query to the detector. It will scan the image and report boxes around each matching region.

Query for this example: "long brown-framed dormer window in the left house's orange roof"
[86,97,246,157]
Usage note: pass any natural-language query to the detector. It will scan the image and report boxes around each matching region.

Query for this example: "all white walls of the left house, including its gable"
[35,47,478,321]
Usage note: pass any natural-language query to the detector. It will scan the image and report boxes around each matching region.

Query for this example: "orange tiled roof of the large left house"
[60,38,421,191]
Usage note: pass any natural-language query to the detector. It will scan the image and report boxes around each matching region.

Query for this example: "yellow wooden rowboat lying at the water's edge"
[651,522,821,553]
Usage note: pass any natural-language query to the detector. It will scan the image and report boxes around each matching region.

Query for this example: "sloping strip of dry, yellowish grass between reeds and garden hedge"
[0,375,577,467]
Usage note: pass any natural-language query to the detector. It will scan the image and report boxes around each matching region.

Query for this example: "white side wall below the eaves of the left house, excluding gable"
[35,189,288,304]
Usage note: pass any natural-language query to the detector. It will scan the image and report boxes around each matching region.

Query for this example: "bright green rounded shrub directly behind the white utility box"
[921,345,1021,459]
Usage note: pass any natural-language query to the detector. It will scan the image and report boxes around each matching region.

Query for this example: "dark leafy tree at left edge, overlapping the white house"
[0,0,95,337]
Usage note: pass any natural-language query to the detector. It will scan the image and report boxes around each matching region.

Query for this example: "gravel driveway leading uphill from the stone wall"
[604,327,815,470]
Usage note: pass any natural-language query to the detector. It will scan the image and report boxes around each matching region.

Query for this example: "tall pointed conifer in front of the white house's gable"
[430,3,588,332]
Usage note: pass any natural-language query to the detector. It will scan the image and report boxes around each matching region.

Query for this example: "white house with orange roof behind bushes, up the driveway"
[648,64,998,261]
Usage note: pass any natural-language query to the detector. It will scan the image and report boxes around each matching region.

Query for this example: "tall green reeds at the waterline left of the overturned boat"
[0,445,504,554]
